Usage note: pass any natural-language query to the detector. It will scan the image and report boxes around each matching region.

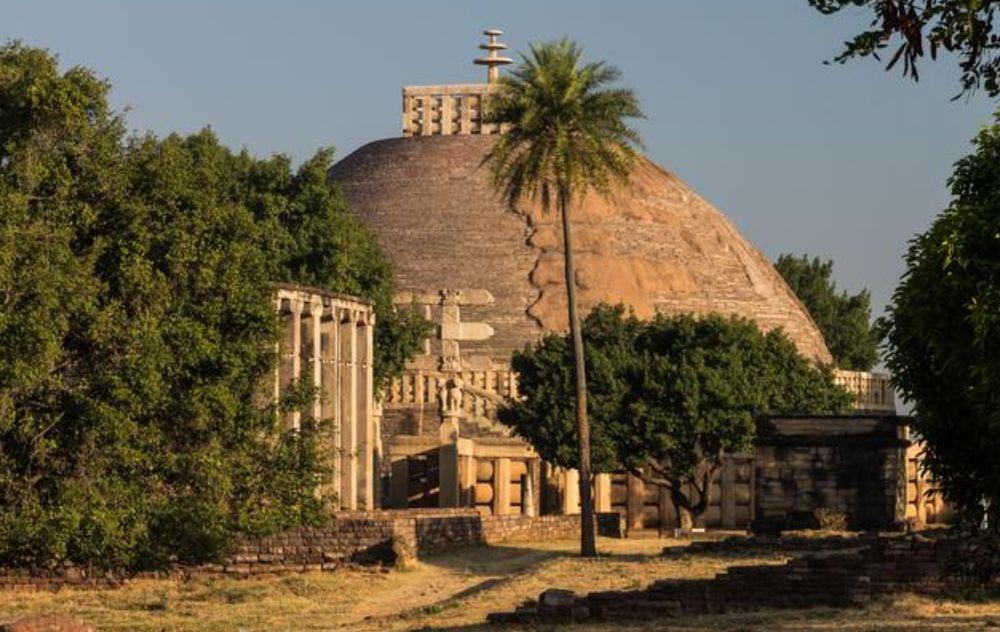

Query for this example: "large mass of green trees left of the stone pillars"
[0,44,426,568]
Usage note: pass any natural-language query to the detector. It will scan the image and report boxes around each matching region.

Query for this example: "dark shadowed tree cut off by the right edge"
[880,111,1000,528]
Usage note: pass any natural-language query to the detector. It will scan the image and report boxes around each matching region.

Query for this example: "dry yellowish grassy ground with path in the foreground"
[0,540,1000,632]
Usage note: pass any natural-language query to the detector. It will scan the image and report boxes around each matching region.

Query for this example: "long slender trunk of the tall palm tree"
[559,191,597,557]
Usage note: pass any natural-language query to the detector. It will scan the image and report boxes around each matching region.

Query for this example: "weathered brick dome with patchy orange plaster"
[330,135,830,362]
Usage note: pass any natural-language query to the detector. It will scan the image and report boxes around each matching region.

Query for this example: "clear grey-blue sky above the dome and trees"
[0,0,995,320]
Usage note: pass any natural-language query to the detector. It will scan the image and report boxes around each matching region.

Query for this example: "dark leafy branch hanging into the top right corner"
[809,0,1000,98]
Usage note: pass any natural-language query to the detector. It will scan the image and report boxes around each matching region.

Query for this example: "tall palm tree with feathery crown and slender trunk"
[483,38,642,557]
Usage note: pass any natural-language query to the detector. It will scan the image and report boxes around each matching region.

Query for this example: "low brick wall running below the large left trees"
[0,509,580,590]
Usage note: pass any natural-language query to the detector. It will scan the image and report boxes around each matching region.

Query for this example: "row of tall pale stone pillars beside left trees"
[273,287,381,509]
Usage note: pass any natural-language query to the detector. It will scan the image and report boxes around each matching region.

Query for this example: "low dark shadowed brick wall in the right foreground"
[489,536,1000,624]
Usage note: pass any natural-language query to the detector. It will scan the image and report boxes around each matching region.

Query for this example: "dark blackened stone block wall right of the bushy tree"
[752,416,909,532]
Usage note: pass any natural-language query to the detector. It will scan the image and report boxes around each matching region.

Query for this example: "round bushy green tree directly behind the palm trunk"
[501,305,850,529]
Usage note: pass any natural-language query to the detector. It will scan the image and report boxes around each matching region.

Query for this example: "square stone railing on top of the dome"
[403,83,503,136]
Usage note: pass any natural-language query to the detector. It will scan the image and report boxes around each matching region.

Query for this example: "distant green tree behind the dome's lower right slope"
[774,254,878,371]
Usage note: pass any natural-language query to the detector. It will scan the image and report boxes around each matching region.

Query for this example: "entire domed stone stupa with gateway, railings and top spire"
[329,30,928,527]
